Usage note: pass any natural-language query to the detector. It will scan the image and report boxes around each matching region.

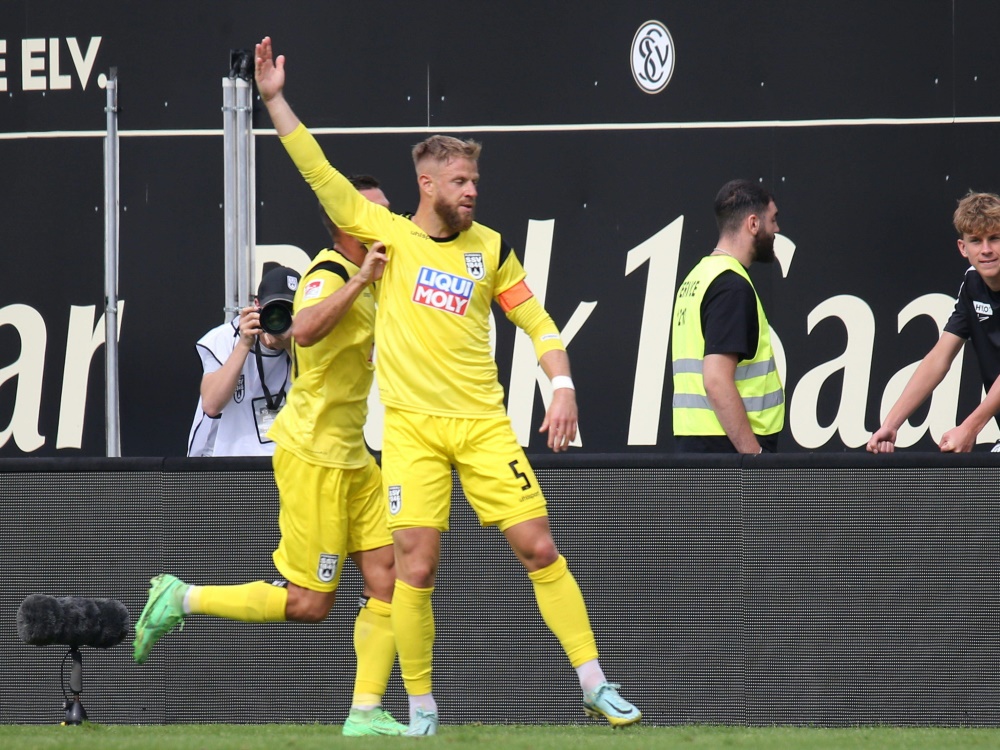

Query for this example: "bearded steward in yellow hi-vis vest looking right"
[671,180,785,453]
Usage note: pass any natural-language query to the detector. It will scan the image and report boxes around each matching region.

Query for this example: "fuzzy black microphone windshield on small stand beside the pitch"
[17,594,129,648]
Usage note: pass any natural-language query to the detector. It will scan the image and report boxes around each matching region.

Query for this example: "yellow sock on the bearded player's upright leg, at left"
[392,578,434,695]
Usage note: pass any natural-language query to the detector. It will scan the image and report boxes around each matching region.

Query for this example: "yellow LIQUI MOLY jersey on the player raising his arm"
[281,125,564,418]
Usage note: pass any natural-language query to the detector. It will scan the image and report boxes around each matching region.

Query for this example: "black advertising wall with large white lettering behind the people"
[0,0,1000,456]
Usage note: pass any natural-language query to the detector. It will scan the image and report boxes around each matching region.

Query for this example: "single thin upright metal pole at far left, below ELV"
[104,68,122,457]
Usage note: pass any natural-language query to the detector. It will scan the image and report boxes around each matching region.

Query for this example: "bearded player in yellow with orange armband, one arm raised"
[256,37,642,735]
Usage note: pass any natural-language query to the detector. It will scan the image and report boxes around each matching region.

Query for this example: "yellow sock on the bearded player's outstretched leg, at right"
[528,555,597,668]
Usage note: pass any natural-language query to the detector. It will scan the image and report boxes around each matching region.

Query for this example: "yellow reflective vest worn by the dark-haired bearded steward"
[672,255,785,435]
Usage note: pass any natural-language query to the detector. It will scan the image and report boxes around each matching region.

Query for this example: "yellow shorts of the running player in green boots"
[272,446,392,591]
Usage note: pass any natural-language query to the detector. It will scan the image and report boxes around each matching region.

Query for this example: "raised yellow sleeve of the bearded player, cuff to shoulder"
[281,123,392,243]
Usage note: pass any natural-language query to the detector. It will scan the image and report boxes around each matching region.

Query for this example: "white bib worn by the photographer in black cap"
[187,317,292,456]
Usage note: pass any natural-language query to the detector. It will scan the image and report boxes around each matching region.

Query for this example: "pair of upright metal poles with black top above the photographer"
[222,50,256,320]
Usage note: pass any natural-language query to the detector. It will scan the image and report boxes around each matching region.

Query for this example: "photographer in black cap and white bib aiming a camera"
[187,266,299,456]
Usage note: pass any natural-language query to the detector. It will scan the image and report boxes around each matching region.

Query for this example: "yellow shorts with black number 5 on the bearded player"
[382,408,547,531]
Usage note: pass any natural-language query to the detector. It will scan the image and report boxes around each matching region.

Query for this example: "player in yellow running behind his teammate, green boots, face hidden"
[134,178,406,736]
